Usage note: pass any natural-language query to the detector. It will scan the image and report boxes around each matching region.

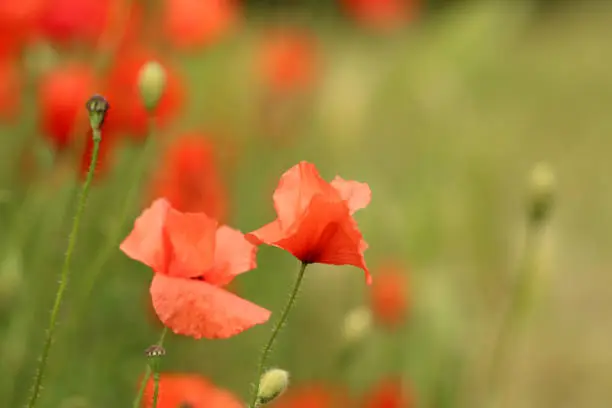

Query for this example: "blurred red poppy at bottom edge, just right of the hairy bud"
[272,384,350,408]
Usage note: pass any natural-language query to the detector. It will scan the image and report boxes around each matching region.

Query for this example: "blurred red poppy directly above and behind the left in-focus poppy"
[153,132,227,221]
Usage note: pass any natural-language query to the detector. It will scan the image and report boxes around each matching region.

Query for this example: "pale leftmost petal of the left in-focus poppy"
[119,198,170,271]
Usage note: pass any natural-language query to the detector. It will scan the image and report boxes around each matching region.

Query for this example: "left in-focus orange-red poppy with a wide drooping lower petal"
[121,199,270,339]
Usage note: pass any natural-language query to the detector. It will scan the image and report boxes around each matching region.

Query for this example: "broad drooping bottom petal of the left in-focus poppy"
[151,274,270,339]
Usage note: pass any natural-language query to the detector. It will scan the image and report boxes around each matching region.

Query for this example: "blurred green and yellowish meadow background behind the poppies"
[0,1,612,408]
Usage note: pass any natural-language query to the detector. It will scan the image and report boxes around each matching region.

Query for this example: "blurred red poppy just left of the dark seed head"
[38,65,95,149]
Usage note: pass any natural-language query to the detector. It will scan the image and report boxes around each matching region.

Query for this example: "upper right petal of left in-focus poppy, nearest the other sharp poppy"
[204,225,257,286]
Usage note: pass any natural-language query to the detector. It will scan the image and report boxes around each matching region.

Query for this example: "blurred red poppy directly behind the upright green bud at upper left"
[105,47,185,140]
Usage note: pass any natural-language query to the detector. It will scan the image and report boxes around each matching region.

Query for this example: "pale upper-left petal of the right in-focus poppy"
[272,161,340,228]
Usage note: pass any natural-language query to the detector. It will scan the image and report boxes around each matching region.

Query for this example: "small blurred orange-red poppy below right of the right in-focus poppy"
[370,264,408,326]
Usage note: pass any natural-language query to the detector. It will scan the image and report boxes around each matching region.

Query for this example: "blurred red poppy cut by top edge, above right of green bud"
[162,0,238,48]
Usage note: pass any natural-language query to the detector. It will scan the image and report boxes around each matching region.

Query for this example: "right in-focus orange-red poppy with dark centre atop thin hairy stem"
[246,162,372,283]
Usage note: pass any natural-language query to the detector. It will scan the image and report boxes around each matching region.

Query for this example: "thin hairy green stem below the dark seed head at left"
[28,130,102,408]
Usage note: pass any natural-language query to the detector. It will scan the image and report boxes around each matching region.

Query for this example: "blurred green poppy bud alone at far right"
[527,163,556,225]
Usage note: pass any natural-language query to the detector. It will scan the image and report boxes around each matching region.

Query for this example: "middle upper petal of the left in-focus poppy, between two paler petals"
[164,209,217,278]
